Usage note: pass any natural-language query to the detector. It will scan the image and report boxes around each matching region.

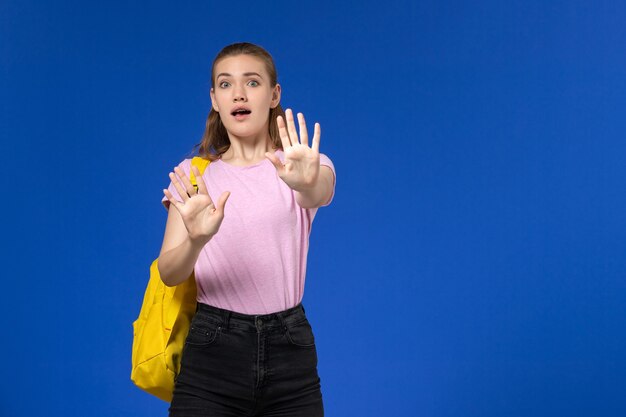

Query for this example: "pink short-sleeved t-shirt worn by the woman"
[161,150,335,314]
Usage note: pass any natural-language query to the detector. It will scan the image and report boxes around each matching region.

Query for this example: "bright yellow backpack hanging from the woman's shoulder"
[130,156,209,402]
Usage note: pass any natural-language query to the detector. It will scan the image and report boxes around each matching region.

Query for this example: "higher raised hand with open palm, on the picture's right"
[265,109,321,191]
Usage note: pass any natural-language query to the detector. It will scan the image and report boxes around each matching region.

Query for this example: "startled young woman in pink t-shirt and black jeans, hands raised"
[158,43,335,417]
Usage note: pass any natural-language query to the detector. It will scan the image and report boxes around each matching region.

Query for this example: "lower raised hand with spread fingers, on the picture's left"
[163,166,230,246]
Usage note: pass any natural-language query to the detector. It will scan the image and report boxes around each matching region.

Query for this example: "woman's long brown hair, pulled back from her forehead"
[188,42,285,161]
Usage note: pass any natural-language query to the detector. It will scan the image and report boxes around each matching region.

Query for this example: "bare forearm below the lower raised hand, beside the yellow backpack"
[157,238,204,287]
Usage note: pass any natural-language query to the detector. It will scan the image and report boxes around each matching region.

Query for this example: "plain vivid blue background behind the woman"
[0,0,626,417]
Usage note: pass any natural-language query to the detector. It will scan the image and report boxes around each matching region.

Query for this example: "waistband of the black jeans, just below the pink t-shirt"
[196,302,306,331]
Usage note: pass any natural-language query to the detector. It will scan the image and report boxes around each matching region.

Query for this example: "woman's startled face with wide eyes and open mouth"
[211,55,280,139]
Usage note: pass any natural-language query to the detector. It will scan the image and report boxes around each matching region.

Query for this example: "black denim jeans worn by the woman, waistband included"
[169,303,324,417]
